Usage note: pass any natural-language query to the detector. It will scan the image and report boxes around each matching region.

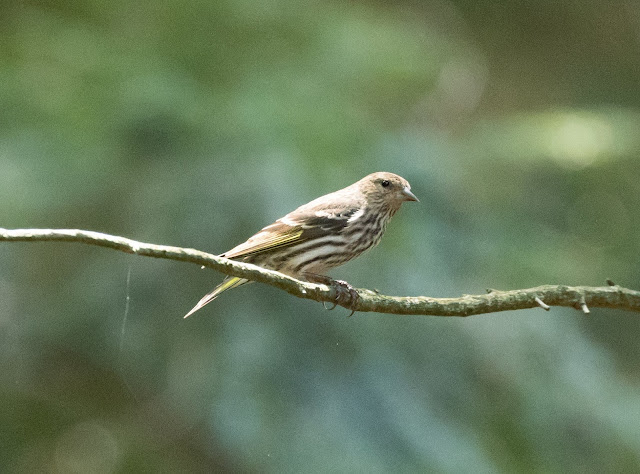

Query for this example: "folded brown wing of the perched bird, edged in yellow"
[220,206,364,259]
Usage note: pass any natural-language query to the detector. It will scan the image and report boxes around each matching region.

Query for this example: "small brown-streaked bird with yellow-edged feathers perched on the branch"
[185,172,418,318]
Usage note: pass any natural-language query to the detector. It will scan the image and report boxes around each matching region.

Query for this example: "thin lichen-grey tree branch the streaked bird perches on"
[0,228,640,316]
